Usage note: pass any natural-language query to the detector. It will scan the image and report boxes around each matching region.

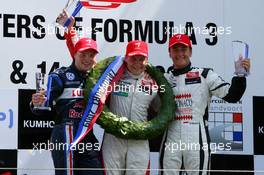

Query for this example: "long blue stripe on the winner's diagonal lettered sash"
[73,56,122,148]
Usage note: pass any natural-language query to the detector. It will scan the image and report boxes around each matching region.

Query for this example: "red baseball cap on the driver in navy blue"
[74,38,98,53]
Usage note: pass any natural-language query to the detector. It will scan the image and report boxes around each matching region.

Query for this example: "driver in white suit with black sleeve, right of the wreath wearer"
[161,34,250,175]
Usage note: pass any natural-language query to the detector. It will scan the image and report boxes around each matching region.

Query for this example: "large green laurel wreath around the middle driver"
[85,57,176,139]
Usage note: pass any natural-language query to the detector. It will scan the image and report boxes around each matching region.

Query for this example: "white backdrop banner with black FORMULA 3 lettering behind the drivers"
[0,0,264,174]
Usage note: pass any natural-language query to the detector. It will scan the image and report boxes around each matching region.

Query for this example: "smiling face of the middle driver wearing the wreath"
[125,55,147,76]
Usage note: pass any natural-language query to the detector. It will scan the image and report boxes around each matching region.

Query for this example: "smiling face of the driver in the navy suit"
[74,49,97,72]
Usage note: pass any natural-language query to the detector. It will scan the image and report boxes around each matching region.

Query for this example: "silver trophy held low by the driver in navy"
[33,72,51,111]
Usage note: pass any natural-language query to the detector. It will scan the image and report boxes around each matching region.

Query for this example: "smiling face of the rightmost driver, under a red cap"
[169,44,192,69]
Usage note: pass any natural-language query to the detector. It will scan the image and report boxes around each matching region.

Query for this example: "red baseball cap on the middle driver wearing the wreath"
[126,40,148,57]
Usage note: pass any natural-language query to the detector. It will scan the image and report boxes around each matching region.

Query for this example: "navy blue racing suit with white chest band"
[31,62,103,175]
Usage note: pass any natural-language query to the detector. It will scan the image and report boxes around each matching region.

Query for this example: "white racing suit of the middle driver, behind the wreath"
[102,71,158,175]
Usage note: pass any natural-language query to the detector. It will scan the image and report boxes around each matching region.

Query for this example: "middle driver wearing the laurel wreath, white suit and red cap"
[56,11,157,175]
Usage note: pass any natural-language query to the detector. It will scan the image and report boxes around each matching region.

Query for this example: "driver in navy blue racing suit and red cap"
[31,15,103,175]
